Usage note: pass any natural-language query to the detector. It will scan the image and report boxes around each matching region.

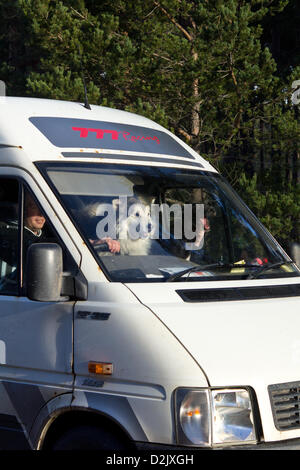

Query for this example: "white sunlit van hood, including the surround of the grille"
[128,280,300,440]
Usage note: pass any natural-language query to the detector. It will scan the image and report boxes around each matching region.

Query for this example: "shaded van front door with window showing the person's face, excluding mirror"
[0,177,74,449]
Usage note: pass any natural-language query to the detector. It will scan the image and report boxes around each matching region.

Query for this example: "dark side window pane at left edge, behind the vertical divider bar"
[0,178,19,295]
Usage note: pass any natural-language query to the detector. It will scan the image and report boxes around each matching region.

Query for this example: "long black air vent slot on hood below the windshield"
[176,284,300,302]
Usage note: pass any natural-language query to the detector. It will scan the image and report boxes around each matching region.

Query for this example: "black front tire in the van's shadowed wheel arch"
[52,425,129,451]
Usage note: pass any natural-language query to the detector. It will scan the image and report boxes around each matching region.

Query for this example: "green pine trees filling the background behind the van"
[0,0,300,248]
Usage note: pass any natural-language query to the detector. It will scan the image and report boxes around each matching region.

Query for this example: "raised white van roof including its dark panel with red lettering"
[0,96,216,172]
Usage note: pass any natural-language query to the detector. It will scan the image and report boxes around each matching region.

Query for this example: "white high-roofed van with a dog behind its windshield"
[0,93,300,450]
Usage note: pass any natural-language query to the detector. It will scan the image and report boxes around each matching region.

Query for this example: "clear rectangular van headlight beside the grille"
[175,388,257,446]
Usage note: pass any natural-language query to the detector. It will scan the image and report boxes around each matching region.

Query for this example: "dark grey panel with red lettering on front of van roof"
[29,116,195,160]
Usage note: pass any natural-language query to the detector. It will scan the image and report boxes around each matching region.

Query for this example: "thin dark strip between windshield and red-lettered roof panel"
[61,152,204,168]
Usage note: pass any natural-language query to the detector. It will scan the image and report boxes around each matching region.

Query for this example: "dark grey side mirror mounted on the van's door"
[26,243,65,302]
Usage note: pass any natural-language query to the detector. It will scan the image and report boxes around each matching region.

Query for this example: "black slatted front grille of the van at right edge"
[268,382,300,431]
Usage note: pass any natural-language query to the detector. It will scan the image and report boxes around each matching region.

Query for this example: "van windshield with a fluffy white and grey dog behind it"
[38,162,300,283]
